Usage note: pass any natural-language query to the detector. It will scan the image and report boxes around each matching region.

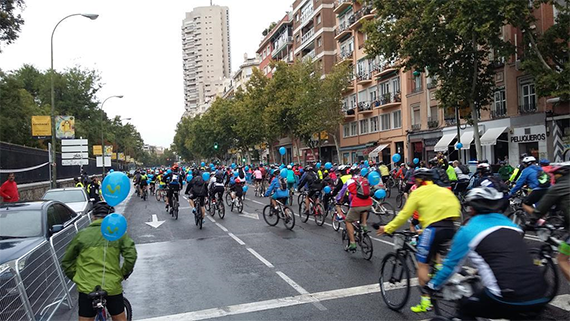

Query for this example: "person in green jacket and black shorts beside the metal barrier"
[61,202,137,321]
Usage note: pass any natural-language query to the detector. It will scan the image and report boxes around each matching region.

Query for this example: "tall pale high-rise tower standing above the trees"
[182,6,231,117]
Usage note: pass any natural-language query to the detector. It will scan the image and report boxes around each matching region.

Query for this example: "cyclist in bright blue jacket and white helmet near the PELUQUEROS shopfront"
[509,156,550,213]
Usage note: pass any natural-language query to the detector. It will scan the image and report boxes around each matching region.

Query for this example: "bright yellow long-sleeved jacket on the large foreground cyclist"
[385,182,461,234]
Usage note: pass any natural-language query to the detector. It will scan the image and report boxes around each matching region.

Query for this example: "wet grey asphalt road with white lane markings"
[57,182,570,321]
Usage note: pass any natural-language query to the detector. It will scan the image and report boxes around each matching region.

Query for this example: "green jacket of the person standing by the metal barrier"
[61,219,137,295]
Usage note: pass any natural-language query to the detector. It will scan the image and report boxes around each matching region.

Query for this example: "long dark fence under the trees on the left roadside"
[0,142,127,184]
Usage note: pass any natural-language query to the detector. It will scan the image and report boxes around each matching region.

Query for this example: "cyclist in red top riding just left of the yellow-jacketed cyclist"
[337,166,372,252]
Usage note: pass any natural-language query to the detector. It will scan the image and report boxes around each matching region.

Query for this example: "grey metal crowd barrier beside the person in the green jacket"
[0,215,90,321]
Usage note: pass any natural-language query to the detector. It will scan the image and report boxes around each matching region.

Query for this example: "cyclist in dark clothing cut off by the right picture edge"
[533,162,570,281]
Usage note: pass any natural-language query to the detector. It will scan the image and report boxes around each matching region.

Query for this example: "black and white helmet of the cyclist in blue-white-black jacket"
[465,187,509,214]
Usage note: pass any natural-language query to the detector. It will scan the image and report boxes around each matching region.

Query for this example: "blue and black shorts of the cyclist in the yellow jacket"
[416,222,455,264]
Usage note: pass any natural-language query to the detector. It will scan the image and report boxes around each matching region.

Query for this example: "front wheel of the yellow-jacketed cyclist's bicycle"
[378,252,411,311]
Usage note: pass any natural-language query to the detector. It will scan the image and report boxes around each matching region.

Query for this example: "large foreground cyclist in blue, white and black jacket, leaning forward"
[426,187,548,320]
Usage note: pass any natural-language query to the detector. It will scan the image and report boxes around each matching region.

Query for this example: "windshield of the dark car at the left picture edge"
[0,209,42,239]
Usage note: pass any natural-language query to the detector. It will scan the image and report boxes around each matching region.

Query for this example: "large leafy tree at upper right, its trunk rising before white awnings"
[364,0,530,159]
